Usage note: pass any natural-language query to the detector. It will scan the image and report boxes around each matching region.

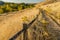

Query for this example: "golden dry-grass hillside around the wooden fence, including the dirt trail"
[0,2,60,40]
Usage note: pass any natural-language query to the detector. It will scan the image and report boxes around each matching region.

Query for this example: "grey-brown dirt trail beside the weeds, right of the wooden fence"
[39,11,60,40]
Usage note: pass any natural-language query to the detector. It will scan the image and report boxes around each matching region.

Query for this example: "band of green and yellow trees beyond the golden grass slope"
[0,3,35,14]
